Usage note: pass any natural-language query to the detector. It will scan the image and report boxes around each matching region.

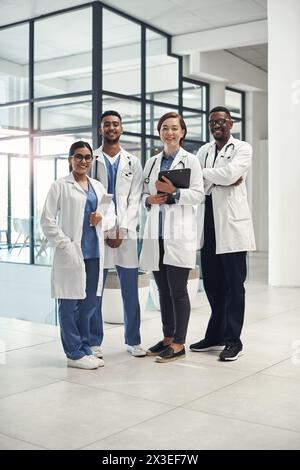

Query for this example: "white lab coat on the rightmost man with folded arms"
[197,136,255,254]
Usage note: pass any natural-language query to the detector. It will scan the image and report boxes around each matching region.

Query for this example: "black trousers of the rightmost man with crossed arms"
[201,200,247,346]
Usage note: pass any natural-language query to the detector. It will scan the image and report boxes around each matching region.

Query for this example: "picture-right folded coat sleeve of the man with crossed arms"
[203,142,252,186]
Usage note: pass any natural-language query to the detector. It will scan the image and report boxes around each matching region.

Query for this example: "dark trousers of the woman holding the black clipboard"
[153,239,191,344]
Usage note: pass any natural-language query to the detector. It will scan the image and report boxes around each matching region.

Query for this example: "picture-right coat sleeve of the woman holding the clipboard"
[177,155,204,205]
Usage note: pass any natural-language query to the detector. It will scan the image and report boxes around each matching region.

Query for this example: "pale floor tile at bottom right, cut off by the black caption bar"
[82,408,300,452]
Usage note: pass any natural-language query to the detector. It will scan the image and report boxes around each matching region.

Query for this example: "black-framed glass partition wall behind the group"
[0,2,208,272]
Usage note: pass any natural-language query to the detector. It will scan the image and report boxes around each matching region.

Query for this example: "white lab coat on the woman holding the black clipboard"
[140,147,204,271]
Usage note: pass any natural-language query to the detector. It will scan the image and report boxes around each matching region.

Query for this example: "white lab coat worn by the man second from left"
[93,147,143,268]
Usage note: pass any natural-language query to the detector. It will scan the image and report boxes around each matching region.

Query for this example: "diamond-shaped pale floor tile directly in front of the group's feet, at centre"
[70,357,248,406]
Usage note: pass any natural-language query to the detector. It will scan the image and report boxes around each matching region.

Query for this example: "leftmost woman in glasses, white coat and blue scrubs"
[41,141,115,369]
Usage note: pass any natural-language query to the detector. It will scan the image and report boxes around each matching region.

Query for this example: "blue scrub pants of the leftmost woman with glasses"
[58,258,101,360]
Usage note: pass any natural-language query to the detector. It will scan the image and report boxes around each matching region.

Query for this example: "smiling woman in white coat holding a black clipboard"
[140,112,204,362]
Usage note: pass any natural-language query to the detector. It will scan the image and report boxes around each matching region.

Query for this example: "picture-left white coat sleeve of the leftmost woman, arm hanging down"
[41,181,71,248]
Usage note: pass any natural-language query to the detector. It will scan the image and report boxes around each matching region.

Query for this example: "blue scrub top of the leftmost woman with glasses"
[81,183,100,259]
